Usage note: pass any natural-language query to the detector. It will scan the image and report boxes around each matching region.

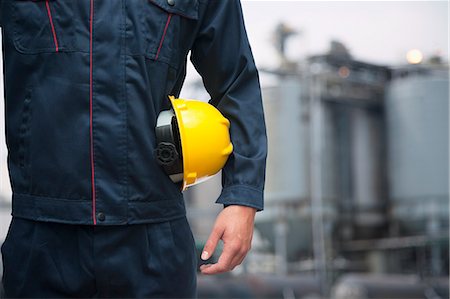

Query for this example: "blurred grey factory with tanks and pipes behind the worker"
[0,0,449,299]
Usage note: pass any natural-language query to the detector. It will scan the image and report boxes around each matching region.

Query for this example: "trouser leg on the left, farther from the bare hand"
[2,217,95,298]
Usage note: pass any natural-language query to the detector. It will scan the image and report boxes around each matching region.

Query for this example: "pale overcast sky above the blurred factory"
[242,0,449,65]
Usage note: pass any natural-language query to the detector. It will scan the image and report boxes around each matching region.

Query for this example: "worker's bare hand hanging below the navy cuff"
[200,205,256,274]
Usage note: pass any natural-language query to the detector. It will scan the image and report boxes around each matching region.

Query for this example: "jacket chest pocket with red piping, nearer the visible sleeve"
[128,0,198,65]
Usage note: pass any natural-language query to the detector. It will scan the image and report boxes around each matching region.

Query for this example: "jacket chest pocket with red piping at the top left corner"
[10,0,88,54]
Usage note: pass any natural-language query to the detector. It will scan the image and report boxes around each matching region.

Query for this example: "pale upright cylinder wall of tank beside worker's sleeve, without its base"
[262,77,309,203]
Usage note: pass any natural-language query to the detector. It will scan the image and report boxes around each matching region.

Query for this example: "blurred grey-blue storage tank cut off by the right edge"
[386,66,449,235]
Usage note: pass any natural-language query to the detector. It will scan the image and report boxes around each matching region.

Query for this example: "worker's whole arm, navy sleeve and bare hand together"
[191,0,267,274]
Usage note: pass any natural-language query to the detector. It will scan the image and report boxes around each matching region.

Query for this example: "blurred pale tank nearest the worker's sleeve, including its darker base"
[256,75,311,258]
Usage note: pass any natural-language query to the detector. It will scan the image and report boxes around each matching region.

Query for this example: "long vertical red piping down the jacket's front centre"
[89,0,97,225]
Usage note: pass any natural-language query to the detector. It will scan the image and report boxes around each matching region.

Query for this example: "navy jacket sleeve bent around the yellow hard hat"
[191,0,267,210]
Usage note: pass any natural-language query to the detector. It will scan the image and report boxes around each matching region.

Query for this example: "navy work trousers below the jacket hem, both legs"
[2,218,197,298]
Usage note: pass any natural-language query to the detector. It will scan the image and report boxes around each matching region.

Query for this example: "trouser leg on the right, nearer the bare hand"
[94,218,197,298]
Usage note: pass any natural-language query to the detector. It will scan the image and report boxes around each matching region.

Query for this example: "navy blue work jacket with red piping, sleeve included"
[0,0,267,225]
